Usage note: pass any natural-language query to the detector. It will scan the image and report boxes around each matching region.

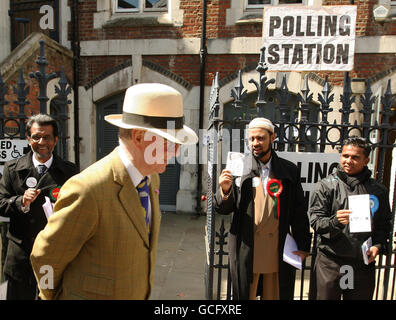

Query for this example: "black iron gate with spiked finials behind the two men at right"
[205,47,396,300]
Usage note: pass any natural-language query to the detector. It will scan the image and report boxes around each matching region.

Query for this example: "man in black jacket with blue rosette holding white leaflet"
[309,136,391,300]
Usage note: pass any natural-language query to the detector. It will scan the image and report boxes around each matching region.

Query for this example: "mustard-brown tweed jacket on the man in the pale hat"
[31,148,161,300]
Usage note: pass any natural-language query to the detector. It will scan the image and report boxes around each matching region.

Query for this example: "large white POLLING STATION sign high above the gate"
[263,6,357,71]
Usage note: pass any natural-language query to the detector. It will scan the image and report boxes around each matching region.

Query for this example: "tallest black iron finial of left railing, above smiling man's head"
[29,40,57,113]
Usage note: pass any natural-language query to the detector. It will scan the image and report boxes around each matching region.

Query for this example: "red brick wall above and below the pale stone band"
[75,0,396,89]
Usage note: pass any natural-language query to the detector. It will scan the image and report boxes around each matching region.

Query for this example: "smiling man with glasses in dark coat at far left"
[0,114,78,300]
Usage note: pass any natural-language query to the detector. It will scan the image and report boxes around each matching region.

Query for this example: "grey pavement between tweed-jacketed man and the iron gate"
[150,212,206,300]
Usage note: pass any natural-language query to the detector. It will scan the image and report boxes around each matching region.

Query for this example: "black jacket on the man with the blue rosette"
[309,167,391,264]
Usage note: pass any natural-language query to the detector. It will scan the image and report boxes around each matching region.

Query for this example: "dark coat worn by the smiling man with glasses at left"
[0,151,78,284]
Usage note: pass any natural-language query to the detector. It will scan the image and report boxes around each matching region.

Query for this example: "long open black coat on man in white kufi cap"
[215,152,311,300]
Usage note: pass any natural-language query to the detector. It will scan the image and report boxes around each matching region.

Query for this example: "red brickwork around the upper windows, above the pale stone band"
[79,0,396,41]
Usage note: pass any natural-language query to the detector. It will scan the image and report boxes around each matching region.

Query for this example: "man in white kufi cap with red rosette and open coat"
[215,118,311,300]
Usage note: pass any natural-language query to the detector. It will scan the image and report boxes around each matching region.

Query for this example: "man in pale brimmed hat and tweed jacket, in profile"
[31,83,198,300]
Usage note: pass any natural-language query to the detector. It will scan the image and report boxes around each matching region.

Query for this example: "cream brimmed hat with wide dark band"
[105,83,198,144]
